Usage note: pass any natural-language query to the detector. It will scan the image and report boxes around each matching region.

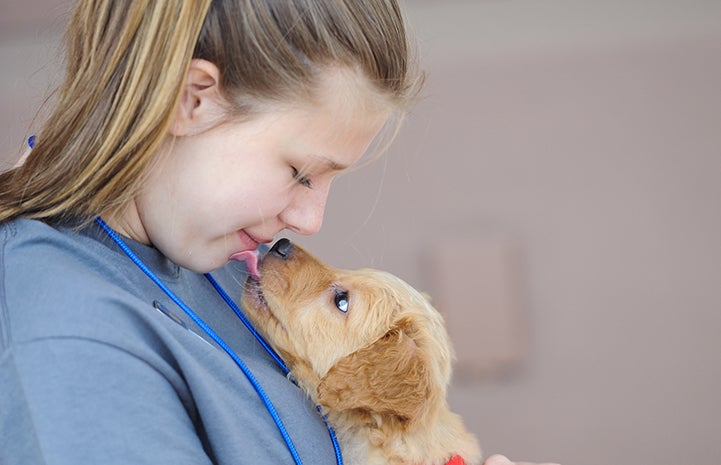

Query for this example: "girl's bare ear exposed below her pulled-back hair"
[169,58,225,136]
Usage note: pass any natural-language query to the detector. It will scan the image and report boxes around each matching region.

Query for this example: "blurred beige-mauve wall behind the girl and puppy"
[0,0,721,465]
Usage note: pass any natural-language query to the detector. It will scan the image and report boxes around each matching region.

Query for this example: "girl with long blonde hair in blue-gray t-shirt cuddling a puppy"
[0,0,552,464]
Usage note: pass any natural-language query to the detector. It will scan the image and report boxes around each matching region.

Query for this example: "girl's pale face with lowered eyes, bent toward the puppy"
[111,67,389,272]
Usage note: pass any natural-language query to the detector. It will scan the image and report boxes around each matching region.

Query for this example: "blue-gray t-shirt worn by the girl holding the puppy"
[0,220,335,465]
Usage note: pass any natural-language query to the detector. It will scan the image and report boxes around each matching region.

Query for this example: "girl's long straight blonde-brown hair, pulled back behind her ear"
[0,0,422,223]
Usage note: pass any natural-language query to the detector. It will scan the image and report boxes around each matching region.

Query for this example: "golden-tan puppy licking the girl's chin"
[242,239,481,465]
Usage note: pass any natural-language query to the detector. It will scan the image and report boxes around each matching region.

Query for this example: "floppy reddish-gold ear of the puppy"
[318,320,430,421]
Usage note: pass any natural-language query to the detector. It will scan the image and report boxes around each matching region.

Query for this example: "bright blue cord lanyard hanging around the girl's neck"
[95,217,343,465]
